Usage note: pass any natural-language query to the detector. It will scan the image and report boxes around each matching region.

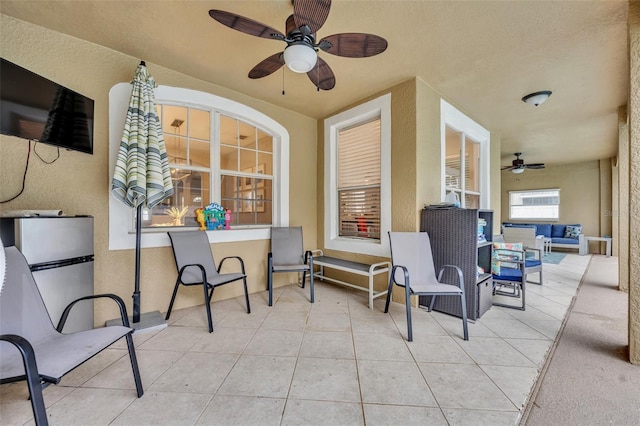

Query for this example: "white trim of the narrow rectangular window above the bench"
[324,94,391,257]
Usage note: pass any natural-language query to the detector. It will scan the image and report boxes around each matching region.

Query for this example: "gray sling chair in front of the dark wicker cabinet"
[384,232,469,342]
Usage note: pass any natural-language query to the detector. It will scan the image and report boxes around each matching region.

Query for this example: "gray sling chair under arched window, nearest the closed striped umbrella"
[165,231,251,333]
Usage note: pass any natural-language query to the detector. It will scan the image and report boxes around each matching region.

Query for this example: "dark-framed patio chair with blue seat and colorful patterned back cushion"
[491,242,528,311]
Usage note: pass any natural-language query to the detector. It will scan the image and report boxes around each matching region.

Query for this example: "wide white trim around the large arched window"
[108,83,289,250]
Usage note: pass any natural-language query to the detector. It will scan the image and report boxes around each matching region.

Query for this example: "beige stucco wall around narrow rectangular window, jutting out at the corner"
[317,79,500,300]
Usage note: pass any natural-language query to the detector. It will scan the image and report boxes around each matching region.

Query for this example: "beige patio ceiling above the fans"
[0,0,629,169]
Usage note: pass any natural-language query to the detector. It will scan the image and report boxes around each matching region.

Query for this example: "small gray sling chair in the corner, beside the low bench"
[267,226,314,306]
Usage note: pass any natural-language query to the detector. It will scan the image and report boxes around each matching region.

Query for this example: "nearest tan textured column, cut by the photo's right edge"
[628,1,640,364]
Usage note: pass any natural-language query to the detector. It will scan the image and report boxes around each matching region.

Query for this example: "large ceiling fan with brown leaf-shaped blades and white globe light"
[209,0,387,90]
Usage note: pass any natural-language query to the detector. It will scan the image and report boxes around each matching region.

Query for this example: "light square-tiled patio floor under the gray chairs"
[0,254,590,426]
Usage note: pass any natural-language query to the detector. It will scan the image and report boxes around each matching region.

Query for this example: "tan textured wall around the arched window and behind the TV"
[0,15,317,324]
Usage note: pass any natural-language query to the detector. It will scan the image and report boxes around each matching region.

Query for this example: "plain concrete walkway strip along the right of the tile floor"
[523,256,640,426]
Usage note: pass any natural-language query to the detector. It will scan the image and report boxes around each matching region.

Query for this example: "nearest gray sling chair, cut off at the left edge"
[0,247,144,425]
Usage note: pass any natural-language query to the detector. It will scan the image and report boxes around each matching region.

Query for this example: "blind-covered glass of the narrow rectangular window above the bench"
[338,117,380,240]
